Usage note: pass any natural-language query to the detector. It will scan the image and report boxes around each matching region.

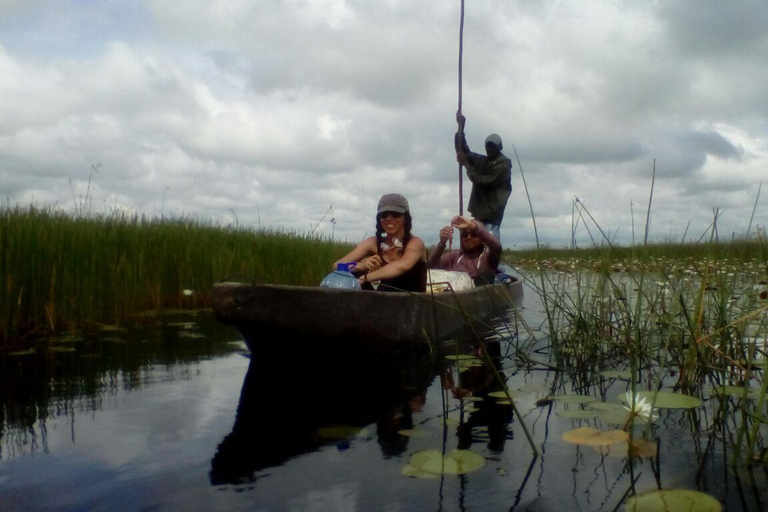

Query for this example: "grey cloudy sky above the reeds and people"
[0,0,768,247]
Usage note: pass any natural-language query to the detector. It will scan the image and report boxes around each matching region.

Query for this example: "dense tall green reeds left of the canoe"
[0,206,349,346]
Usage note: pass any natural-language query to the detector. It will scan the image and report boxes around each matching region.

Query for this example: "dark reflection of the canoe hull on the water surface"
[210,342,437,485]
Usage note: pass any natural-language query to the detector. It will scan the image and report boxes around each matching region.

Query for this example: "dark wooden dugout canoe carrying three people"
[212,278,523,353]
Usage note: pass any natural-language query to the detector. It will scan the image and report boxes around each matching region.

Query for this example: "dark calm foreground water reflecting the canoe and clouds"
[0,306,768,511]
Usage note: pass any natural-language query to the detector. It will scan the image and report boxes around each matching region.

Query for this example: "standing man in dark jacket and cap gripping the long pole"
[454,112,512,240]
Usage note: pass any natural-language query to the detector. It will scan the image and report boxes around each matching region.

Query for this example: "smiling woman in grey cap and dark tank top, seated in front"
[333,194,427,292]
